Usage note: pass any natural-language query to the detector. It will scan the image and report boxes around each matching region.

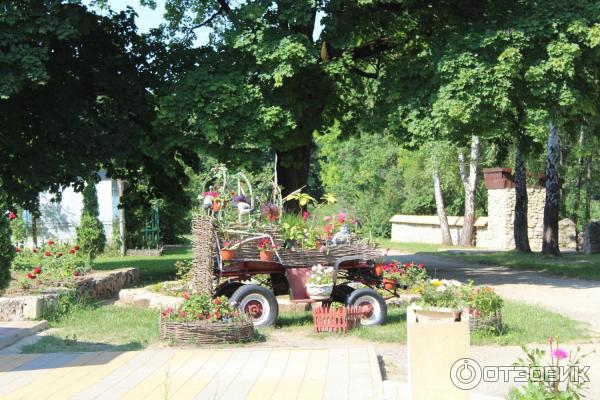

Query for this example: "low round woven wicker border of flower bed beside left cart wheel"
[160,317,254,344]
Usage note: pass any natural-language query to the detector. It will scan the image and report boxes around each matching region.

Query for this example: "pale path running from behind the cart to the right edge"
[389,252,600,333]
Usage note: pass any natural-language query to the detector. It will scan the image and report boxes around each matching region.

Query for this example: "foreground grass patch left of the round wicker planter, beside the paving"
[21,306,158,353]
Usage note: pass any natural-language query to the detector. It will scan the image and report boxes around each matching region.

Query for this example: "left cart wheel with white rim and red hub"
[230,285,279,326]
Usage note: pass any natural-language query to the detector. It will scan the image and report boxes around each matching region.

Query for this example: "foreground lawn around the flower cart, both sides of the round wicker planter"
[22,301,590,353]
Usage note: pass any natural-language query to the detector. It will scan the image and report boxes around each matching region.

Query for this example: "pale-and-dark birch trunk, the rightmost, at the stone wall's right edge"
[542,123,560,256]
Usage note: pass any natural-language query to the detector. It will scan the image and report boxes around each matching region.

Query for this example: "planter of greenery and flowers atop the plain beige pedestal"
[412,279,467,322]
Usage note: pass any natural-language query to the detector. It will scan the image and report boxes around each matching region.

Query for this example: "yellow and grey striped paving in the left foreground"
[0,347,383,400]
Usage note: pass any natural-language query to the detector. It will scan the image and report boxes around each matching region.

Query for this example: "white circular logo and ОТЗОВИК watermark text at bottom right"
[450,358,590,390]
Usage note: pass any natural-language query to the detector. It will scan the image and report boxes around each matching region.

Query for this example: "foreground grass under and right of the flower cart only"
[270,301,590,345]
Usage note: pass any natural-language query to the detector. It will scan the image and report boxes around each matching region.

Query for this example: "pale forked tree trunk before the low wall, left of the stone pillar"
[458,135,479,246]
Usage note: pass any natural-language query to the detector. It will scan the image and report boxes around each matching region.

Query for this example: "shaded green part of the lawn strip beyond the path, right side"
[436,251,600,280]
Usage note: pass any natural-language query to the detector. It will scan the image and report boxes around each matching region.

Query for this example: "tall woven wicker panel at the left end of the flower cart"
[192,216,214,295]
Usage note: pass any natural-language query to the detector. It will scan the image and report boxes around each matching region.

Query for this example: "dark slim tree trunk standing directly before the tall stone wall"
[514,144,531,253]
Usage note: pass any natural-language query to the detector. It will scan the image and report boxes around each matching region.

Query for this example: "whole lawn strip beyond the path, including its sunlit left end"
[377,238,600,280]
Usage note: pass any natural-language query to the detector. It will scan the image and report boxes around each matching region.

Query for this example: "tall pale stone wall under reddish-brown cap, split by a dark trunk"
[477,188,546,250]
